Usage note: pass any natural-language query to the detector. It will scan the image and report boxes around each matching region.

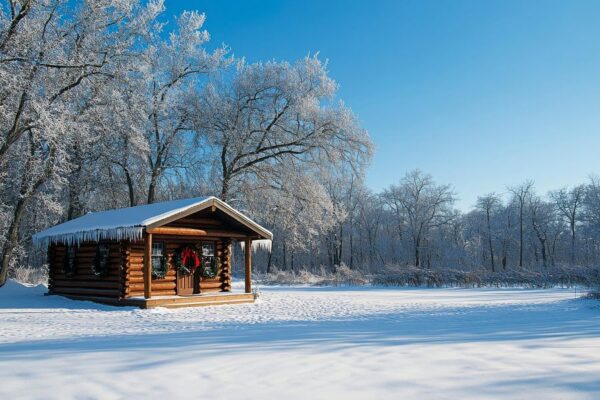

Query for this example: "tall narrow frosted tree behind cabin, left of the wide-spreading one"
[135,11,228,203]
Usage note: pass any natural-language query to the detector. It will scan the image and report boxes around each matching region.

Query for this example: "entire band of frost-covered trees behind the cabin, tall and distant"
[0,0,600,285]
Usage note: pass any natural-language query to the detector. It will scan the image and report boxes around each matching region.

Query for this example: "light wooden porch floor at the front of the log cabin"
[120,292,254,308]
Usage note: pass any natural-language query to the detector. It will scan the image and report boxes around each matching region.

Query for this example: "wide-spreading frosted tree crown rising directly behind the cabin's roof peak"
[195,56,371,200]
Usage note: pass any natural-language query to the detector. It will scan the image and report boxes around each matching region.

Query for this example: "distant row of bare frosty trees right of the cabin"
[262,170,600,280]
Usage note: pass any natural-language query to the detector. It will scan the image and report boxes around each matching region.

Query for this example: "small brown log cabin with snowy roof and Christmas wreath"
[33,197,273,308]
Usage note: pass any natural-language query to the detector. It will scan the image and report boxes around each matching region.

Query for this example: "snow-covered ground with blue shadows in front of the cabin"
[0,282,600,400]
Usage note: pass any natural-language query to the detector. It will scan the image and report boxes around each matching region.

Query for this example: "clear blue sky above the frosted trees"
[166,0,600,210]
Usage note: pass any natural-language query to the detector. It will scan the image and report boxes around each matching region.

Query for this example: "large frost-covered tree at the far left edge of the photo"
[0,0,162,285]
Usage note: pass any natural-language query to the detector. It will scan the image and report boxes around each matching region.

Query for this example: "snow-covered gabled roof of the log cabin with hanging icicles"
[32,196,273,247]
